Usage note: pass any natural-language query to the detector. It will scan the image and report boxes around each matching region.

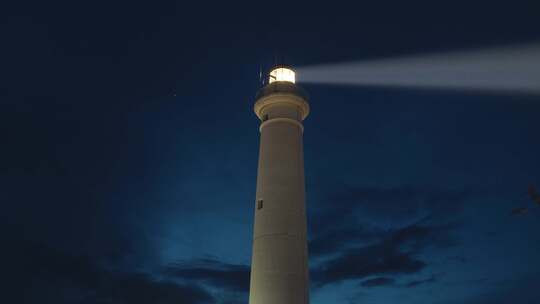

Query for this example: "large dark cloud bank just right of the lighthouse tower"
[309,187,470,287]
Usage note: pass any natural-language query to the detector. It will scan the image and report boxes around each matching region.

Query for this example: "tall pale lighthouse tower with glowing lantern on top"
[249,67,309,304]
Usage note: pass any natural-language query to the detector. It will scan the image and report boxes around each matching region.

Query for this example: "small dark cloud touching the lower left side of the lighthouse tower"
[164,259,250,293]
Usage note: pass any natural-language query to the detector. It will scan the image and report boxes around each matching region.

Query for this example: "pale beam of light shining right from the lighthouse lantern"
[297,44,540,94]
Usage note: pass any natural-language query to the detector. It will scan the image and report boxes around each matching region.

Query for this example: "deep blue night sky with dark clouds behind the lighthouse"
[0,0,540,304]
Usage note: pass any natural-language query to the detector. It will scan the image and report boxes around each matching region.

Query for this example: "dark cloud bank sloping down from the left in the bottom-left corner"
[5,241,214,304]
